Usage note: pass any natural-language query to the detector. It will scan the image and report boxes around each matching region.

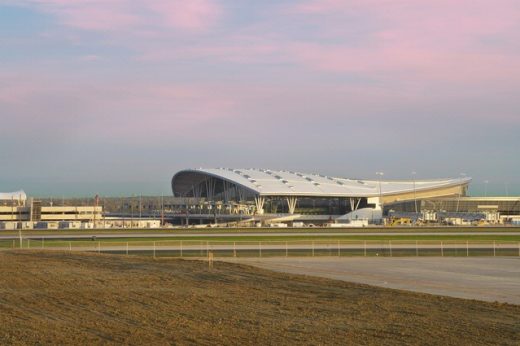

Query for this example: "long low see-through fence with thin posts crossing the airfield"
[0,238,520,258]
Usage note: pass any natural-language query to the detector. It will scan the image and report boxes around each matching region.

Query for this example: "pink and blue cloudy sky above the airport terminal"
[0,0,520,196]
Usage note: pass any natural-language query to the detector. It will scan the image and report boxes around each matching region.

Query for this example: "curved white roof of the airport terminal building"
[172,168,471,197]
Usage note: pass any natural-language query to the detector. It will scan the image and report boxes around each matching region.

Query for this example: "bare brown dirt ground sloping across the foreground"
[0,251,520,345]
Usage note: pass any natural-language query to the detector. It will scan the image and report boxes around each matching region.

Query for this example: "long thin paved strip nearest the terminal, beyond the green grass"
[0,230,520,239]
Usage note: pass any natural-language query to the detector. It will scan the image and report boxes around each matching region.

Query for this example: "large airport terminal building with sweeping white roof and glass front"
[172,168,471,223]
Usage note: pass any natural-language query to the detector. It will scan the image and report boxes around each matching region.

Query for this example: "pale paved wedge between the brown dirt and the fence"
[226,257,520,305]
